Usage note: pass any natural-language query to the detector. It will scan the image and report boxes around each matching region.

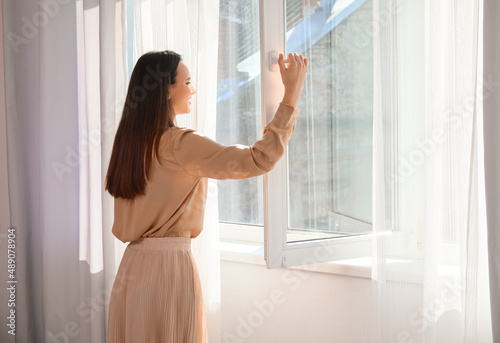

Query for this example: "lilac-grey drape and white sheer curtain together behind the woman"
[1,0,220,343]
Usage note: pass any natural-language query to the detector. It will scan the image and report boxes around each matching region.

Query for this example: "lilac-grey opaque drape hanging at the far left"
[1,1,81,342]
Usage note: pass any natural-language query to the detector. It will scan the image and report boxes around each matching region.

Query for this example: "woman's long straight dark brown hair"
[106,50,181,199]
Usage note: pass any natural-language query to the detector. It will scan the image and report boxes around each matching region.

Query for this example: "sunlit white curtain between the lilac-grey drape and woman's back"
[76,1,127,342]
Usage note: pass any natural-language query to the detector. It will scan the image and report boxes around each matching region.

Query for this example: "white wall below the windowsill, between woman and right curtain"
[221,261,373,343]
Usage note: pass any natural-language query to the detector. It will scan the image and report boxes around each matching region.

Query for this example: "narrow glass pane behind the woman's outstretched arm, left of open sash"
[216,0,264,225]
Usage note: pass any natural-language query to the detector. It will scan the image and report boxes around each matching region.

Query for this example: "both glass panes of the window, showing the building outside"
[216,0,373,242]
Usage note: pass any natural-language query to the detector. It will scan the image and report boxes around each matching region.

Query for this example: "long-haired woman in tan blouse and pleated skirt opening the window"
[106,51,308,343]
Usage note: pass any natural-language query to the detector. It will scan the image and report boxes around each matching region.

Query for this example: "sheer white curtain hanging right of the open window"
[373,0,492,343]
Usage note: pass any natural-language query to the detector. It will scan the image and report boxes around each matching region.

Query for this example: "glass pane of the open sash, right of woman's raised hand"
[285,0,373,242]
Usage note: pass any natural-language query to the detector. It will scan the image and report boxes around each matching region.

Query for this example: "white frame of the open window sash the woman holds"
[260,0,404,269]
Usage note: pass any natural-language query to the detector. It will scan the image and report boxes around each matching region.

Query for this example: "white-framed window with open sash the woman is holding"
[217,0,373,268]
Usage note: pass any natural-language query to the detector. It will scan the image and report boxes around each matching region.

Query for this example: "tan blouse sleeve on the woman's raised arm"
[173,103,299,180]
